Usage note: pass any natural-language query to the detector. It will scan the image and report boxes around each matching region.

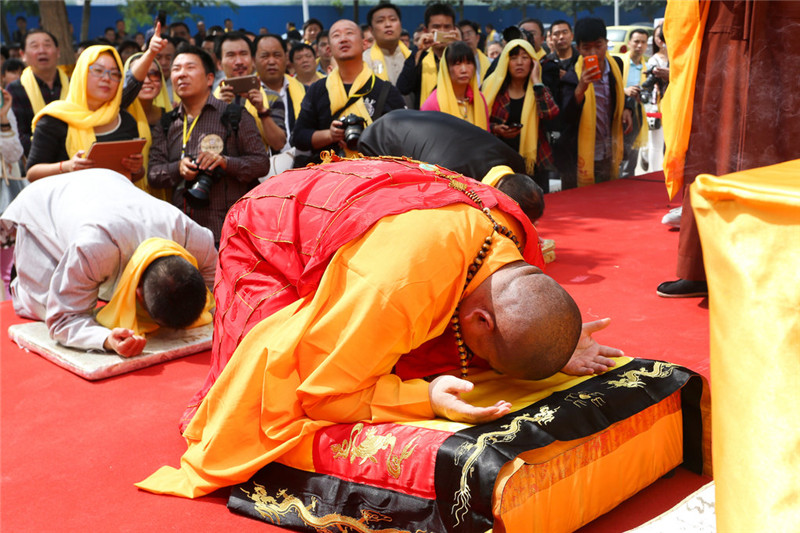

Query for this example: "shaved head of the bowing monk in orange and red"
[460,262,581,379]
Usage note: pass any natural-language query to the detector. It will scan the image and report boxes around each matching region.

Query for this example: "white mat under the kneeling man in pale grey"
[8,322,213,381]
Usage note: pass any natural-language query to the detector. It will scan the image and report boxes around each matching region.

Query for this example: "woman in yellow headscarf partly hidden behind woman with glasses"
[125,53,172,202]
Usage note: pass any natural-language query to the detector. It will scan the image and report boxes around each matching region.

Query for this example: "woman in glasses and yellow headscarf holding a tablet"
[27,27,169,185]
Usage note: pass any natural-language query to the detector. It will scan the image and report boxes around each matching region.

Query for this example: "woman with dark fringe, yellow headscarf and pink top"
[420,41,489,131]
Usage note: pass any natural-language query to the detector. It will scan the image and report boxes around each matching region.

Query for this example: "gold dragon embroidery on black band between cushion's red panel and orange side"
[450,405,561,526]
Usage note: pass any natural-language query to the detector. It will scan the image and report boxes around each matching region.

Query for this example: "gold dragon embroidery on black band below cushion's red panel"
[242,483,425,533]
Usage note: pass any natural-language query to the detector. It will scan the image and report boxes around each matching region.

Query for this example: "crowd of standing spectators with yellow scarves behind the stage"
[0,3,669,284]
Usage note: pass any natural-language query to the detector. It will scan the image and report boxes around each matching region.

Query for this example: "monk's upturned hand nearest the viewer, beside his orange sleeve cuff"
[428,375,511,424]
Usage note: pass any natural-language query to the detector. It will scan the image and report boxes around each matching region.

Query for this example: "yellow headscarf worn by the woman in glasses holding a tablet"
[32,45,122,158]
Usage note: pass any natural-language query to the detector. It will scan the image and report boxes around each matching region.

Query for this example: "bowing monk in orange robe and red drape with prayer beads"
[138,156,621,497]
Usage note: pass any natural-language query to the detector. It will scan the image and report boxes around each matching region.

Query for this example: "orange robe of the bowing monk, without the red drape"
[137,204,523,497]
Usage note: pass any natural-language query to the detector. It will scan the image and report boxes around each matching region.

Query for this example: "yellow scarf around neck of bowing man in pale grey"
[96,237,214,335]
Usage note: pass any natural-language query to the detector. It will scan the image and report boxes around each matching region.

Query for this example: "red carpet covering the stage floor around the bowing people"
[0,174,709,532]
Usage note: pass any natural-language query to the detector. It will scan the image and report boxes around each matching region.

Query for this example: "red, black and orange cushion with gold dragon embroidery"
[228,358,703,532]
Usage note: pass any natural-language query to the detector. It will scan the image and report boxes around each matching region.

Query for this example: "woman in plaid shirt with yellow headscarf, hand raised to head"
[483,39,558,177]
